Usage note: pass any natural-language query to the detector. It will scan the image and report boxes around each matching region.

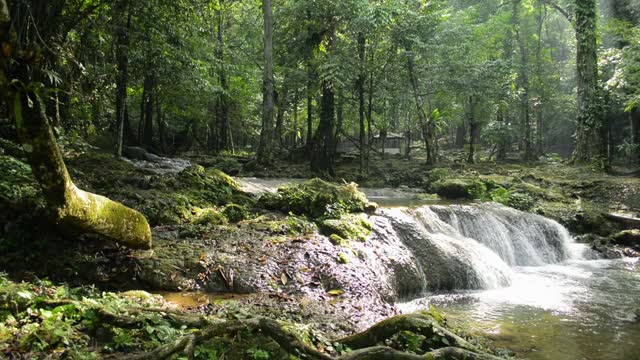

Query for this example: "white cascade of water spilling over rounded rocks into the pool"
[371,203,573,293]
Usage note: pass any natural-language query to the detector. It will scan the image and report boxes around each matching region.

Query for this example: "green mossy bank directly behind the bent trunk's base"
[68,151,254,226]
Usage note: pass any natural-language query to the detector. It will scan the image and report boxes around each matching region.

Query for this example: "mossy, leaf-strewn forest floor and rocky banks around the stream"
[0,139,640,359]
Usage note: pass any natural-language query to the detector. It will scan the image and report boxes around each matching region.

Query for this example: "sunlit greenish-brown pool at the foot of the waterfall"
[401,259,640,360]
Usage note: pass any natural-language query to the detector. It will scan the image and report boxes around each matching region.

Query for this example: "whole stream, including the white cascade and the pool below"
[219,179,640,360]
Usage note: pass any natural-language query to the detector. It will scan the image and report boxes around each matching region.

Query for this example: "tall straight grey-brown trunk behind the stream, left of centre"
[257,0,275,165]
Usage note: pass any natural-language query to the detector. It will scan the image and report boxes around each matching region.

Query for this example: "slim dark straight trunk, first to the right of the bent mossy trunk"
[114,0,131,157]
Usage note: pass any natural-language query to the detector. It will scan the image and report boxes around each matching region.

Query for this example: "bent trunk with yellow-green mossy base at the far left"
[0,0,151,249]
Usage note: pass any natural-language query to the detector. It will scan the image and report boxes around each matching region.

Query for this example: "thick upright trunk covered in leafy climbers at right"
[571,0,606,166]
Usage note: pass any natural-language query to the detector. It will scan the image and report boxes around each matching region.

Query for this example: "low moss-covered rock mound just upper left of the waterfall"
[258,179,368,218]
